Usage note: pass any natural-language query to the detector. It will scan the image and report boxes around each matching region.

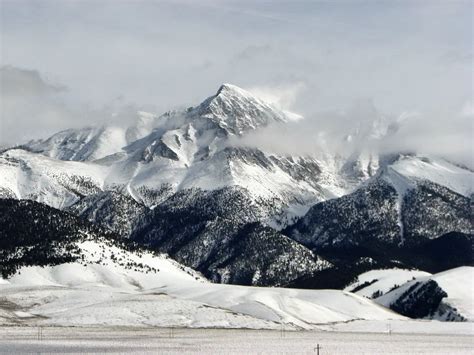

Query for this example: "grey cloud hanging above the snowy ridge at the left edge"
[0,65,137,145]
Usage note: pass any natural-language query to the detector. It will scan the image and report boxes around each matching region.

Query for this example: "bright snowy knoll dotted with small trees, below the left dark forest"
[8,240,207,290]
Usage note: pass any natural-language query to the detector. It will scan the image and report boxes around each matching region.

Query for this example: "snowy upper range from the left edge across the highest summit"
[0,84,341,226]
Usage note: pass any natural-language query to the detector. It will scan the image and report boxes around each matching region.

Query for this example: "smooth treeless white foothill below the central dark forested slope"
[159,284,400,329]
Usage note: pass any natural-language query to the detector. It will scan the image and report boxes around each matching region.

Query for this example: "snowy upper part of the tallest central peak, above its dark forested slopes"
[101,84,333,223]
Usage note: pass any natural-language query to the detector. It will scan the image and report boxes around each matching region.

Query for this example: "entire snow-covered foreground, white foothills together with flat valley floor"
[0,246,474,354]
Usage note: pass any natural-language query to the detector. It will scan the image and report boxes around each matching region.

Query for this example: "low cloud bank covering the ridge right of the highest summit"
[231,101,474,168]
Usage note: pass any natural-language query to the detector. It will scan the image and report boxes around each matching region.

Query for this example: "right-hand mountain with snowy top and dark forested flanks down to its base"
[283,155,474,288]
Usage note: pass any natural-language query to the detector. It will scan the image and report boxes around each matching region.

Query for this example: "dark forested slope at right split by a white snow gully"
[285,177,473,254]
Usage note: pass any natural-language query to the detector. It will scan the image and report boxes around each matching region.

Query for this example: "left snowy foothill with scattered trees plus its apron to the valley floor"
[0,241,274,328]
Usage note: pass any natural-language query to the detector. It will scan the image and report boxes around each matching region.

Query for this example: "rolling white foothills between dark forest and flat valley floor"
[0,241,404,329]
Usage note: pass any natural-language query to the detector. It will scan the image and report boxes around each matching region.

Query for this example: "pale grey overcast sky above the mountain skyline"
[0,0,473,148]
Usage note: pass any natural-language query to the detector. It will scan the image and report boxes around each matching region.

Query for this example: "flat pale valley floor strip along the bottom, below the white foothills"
[0,322,474,355]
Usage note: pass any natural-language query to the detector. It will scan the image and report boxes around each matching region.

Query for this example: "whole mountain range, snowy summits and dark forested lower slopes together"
[0,84,474,288]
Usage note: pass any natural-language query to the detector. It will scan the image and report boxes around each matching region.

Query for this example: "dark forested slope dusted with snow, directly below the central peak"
[130,188,327,286]
